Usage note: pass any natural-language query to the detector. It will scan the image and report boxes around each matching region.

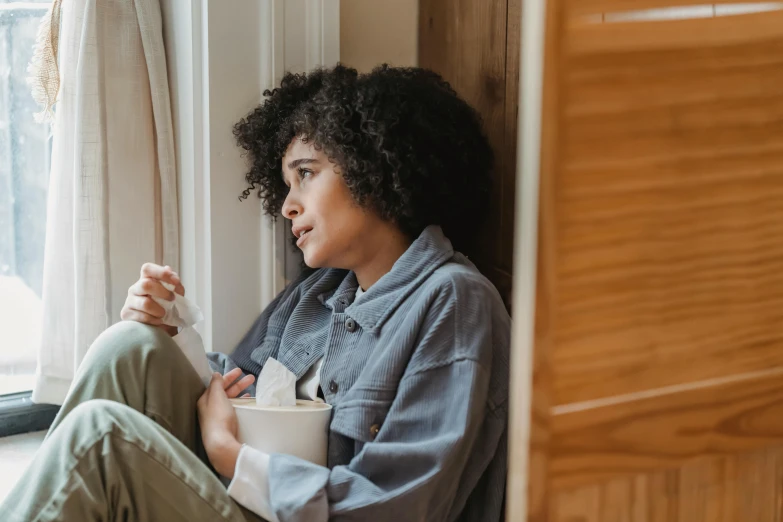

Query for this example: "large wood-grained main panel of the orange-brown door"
[548,9,783,405]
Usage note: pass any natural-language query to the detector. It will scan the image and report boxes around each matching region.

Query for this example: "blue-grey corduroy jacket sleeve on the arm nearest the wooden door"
[268,280,492,522]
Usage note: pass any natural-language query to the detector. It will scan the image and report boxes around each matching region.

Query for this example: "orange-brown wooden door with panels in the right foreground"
[509,0,783,522]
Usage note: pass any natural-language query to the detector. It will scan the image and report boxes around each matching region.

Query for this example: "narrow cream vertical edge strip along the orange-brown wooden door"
[507,0,546,520]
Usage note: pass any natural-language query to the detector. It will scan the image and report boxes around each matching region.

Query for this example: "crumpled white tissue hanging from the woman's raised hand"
[152,281,212,386]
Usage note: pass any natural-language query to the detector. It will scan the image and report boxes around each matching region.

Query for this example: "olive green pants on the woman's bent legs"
[0,322,261,522]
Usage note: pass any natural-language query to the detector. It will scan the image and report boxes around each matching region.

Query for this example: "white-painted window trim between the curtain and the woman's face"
[161,0,340,351]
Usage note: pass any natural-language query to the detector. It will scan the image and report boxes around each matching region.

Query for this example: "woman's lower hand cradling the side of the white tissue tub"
[196,368,254,479]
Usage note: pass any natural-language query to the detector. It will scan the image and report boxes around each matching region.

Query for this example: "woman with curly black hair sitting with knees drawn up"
[0,66,509,522]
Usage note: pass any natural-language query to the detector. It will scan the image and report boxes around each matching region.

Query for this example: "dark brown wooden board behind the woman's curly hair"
[419,0,521,307]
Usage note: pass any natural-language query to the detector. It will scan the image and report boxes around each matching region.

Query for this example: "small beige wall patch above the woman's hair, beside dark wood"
[340,0,419,71]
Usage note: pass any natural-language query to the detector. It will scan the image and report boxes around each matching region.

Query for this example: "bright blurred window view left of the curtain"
[0,0,51,395]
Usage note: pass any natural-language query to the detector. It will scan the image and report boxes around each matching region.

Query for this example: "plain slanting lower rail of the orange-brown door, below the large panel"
[549,368,783,488]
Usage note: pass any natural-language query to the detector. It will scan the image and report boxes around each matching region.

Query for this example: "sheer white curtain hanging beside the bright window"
[33,0,179,404]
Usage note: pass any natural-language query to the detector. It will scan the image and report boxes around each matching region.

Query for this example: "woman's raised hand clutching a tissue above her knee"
[120,263,185,337]
